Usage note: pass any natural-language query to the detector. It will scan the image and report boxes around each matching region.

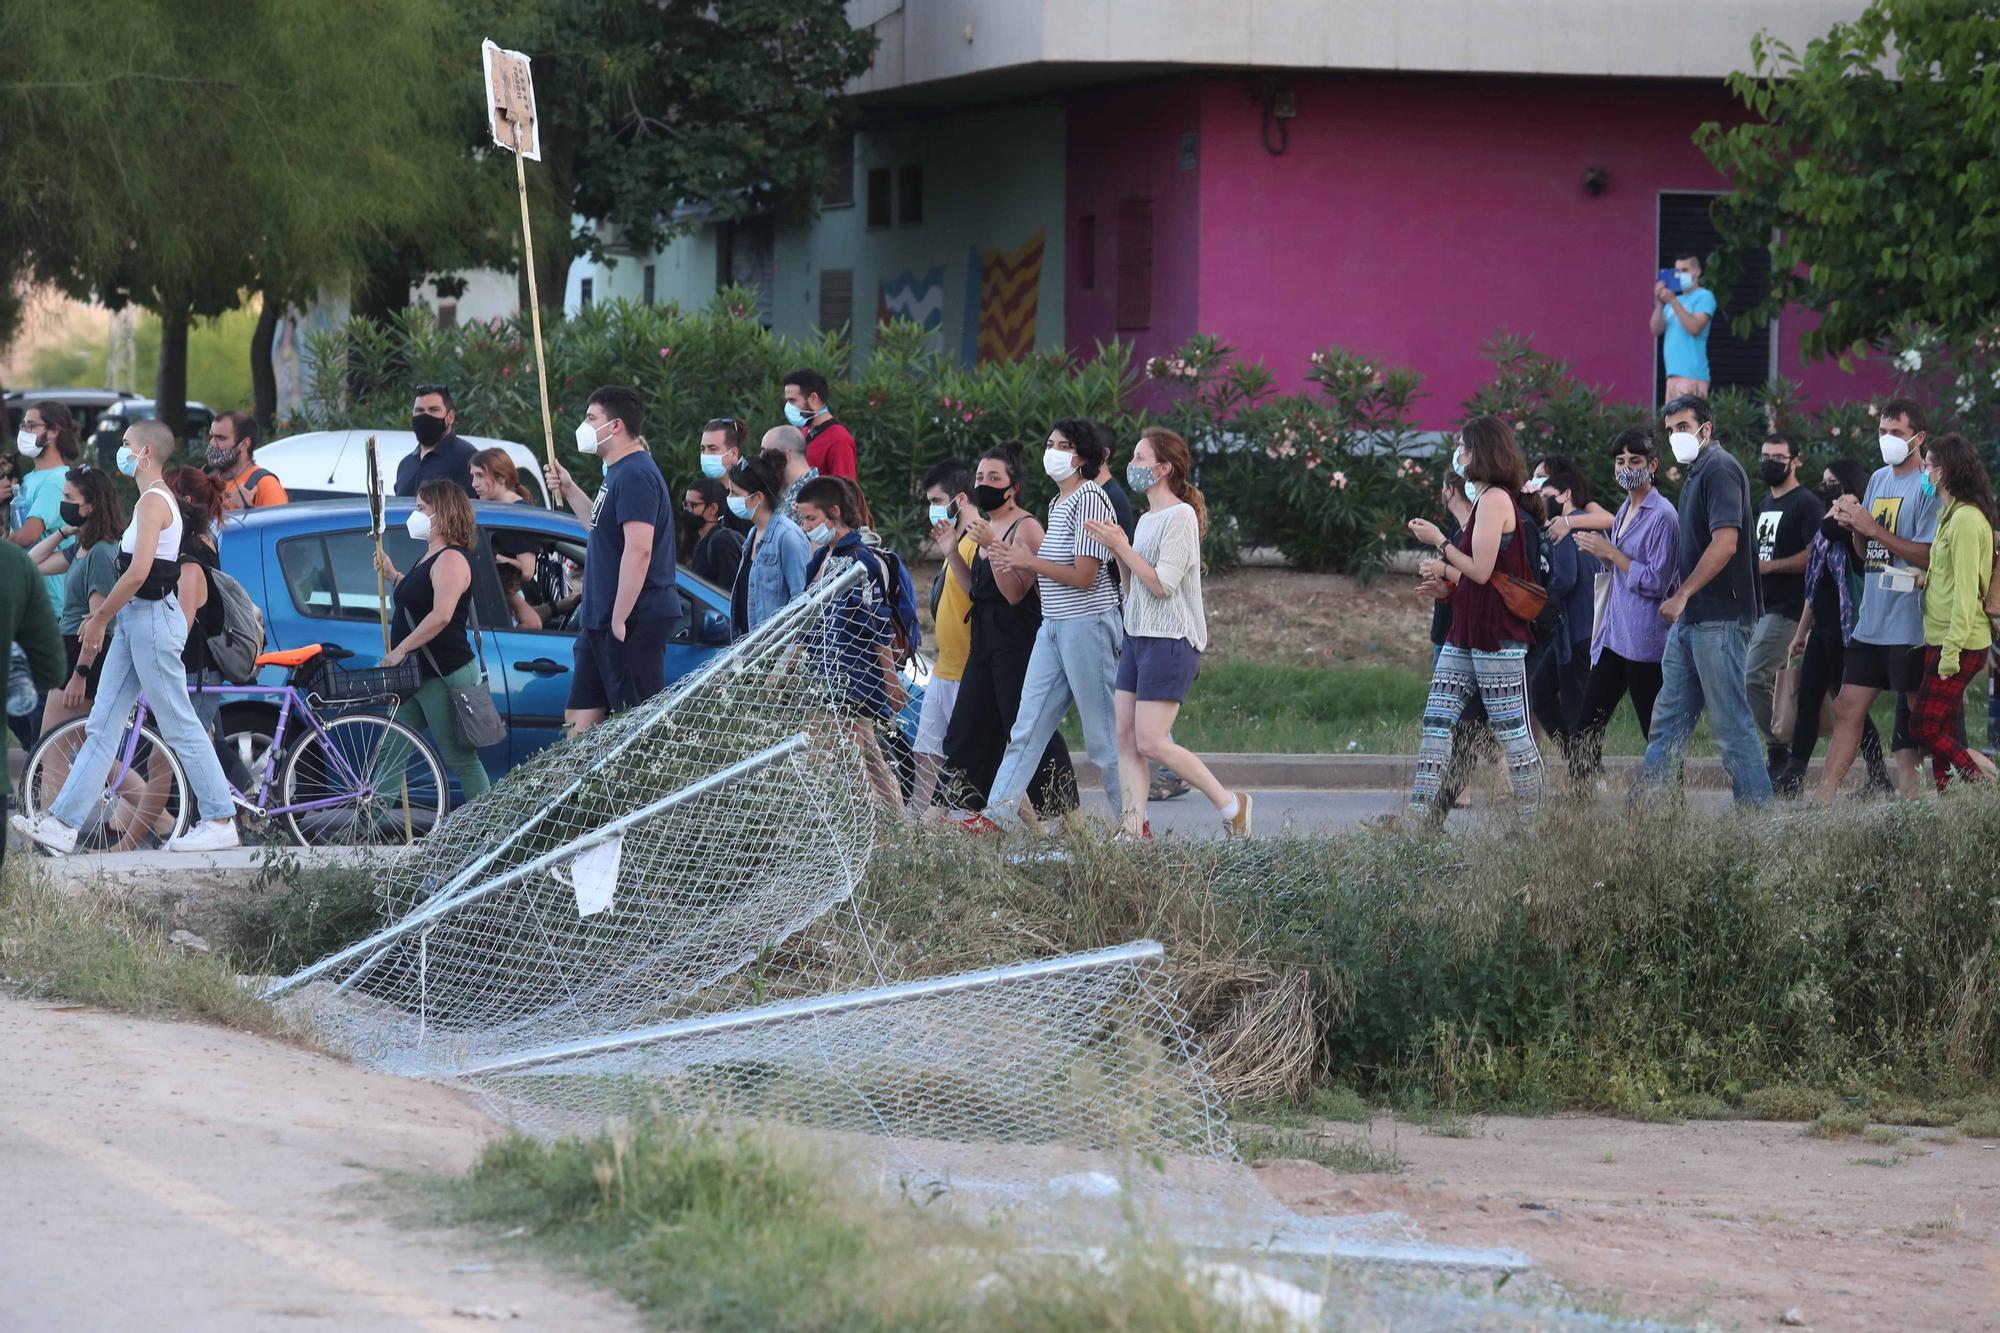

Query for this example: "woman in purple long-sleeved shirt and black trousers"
[1570,426,1680,783]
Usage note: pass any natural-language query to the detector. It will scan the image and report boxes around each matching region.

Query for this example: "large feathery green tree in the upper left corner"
[0,0,502,428]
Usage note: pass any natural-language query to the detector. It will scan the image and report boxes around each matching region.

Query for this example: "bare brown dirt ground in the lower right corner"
[1260,1117,2000,1331]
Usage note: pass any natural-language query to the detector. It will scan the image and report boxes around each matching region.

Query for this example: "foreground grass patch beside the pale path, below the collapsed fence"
[422,1121,1282,1333]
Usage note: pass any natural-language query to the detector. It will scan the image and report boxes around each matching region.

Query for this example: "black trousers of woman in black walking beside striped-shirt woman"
[938,620,1076,819]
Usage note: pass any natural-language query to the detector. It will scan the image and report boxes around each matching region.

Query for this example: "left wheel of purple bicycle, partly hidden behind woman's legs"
[18,717,194,851]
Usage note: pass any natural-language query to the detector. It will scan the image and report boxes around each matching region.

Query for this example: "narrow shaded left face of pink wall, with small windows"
[1062,80,1204,394]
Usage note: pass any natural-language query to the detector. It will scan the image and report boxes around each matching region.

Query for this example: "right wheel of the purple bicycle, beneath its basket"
[278,713,448,847]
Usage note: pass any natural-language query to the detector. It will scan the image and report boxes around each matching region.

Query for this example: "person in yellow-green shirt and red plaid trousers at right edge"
[1910,432,1994,791]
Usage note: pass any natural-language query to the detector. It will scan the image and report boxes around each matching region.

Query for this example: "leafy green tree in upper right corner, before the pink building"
[1696,0,2000,356]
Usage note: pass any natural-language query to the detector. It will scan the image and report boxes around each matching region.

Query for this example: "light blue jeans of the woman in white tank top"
[48,596,236,829]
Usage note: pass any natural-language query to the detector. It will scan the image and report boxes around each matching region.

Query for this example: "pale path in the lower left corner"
[0,999,638,1333]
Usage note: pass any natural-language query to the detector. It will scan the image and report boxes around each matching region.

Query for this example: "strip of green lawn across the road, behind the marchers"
[1064,660,1986,757]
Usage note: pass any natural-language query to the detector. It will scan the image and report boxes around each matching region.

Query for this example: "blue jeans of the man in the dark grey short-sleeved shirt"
[1632,620,1770,805]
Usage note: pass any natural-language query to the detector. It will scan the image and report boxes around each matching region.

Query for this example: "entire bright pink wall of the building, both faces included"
[1068,76,1886,426]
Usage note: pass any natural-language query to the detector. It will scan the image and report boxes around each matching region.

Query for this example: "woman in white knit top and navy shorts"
[1084,426,1250,839]
